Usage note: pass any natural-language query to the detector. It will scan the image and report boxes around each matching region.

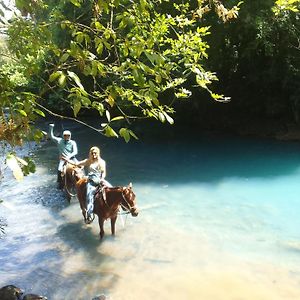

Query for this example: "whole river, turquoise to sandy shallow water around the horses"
[0,123,300,300]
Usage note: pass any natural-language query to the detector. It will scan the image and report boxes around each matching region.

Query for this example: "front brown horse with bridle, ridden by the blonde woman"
[76,178,138,239]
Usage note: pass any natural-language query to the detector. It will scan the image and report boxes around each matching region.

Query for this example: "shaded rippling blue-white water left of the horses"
[0,163,122,300]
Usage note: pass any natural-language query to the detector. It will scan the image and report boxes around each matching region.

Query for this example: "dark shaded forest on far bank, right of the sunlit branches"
[171,0,300,135]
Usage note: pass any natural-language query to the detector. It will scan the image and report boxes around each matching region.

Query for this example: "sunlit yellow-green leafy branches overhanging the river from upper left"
[1,0,239,141]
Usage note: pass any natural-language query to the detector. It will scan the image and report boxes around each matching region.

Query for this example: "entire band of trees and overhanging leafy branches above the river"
[0,0,300,178]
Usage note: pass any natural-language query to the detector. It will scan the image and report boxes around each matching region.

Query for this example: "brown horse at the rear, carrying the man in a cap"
[62,163,84,202]
